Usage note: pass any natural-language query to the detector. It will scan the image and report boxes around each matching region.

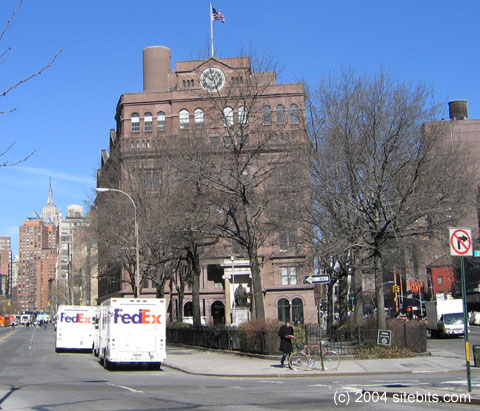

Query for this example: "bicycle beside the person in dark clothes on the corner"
[288,341,340,371]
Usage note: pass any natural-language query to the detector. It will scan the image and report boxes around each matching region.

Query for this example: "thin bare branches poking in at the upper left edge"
[0,0,62,167]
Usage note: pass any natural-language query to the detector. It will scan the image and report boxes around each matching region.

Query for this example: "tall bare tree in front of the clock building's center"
[179,53,305,319]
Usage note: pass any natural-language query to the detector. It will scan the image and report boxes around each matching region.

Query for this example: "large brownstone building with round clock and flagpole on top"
[97,47,317,324]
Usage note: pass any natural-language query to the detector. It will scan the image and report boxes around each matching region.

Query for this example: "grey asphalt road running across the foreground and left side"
[0,327,480,411]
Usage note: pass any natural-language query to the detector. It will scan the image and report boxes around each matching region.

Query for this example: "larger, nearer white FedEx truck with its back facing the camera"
[98,298,166,369]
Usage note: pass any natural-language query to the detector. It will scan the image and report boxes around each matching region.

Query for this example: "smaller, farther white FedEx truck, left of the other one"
[55,305,95,352]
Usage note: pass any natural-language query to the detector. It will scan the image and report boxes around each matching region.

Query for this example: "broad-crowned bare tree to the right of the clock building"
[310,72,474,328]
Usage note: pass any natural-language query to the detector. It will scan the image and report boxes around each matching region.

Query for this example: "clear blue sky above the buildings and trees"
[0,0,480,254]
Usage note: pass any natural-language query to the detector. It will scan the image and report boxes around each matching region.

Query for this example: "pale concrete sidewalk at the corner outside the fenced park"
[164,345,480,404]
